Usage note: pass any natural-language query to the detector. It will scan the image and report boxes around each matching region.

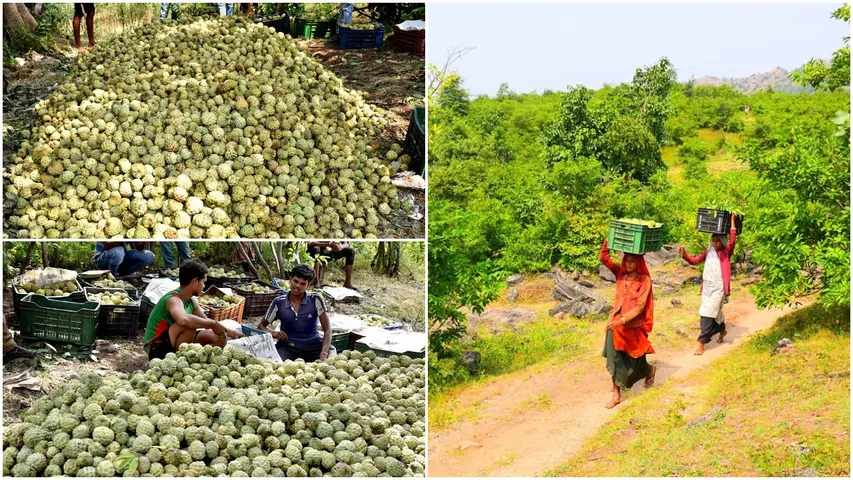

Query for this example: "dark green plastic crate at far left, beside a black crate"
[21,293,101,346]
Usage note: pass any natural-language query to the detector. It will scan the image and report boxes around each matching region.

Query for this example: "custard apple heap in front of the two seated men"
[3,345,426,477]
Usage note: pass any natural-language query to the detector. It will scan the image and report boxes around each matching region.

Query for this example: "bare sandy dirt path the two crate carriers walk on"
[429,300,790,477]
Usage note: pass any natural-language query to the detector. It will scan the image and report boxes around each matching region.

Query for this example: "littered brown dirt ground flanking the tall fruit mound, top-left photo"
[3,26,426,238]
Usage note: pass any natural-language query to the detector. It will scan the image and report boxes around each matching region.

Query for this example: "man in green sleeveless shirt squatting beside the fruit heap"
[143,259,243,359]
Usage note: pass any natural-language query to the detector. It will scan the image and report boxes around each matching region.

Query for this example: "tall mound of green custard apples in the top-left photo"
[4,16,411,239]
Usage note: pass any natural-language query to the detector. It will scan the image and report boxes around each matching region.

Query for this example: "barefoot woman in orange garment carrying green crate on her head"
[599,239,657,408]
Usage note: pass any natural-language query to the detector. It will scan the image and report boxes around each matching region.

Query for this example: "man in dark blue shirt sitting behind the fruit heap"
[259,264,332,362]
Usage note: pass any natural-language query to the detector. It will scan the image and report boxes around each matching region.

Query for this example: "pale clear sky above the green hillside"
[427,2,850,95]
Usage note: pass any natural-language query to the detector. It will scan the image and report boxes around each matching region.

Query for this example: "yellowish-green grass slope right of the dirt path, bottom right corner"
[549,305,850,477]
